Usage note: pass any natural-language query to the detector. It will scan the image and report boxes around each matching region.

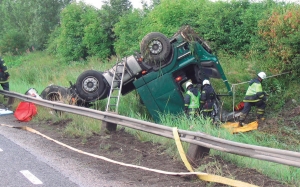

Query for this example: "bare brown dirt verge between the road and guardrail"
[0,112,286,187]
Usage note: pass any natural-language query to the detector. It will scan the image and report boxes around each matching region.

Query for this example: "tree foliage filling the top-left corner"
[0,0,72,52]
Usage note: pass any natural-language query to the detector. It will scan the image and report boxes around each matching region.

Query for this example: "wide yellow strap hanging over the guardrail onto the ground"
[173,127,257,187]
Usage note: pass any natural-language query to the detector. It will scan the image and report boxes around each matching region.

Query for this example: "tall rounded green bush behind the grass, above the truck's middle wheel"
[48,3,110,62]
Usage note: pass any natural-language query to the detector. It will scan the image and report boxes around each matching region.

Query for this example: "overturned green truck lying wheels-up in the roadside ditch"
[41,26,231,120]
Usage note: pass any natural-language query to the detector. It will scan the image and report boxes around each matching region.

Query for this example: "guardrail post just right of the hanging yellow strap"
[187,137,210,164]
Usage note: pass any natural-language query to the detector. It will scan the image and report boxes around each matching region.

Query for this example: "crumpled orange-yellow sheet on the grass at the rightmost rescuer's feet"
[222,121,258,134]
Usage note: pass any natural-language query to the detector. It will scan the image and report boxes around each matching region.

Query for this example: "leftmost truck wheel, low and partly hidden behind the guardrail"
[40,85,68,101]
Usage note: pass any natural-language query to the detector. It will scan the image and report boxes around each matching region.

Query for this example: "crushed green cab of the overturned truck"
[133,28,231,119]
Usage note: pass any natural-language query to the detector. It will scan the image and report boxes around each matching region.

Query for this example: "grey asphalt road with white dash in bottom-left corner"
[0,134,78,187]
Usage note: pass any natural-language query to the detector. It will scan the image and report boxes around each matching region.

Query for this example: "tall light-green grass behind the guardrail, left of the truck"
[3,52,112,93]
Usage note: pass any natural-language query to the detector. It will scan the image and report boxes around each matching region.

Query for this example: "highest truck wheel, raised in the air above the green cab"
[140,32,171,66]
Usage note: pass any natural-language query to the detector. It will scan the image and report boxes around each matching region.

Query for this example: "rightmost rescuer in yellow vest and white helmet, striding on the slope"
[239,72,267,126]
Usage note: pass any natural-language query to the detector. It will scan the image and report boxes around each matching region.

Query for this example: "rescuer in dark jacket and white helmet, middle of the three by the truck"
[200,80,216,118]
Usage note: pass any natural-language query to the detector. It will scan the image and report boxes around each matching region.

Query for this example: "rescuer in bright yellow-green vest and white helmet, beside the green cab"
[184,82,201,117]
